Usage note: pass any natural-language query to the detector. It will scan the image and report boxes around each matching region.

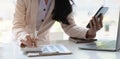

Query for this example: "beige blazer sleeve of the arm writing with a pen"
[12,0,32,45]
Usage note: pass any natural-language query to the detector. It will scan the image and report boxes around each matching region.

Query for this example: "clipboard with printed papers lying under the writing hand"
[22,44,72,57]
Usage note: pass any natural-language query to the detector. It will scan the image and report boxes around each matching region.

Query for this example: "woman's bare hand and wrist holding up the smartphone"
[86,15,103,38]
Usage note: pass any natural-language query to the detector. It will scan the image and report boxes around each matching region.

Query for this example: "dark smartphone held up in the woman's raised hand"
[86,6,109,28]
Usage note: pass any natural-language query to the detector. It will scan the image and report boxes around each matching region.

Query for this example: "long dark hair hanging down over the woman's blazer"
[52,0,73,25]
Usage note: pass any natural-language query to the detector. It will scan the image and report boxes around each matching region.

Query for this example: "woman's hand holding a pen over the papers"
[21,35,37,48]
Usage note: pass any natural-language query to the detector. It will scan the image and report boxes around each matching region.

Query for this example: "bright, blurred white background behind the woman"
[0,0,120,43]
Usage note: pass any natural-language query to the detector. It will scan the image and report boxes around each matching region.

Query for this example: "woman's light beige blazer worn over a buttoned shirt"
[12,0,87,44]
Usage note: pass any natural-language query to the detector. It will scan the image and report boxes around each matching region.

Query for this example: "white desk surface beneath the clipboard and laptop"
[0,40,120,59]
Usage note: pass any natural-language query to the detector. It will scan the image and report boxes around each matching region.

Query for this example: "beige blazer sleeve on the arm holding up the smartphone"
[61,14,88,38]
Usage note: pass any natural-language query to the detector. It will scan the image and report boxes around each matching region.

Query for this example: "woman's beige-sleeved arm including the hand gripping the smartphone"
[61,15,103,39]
